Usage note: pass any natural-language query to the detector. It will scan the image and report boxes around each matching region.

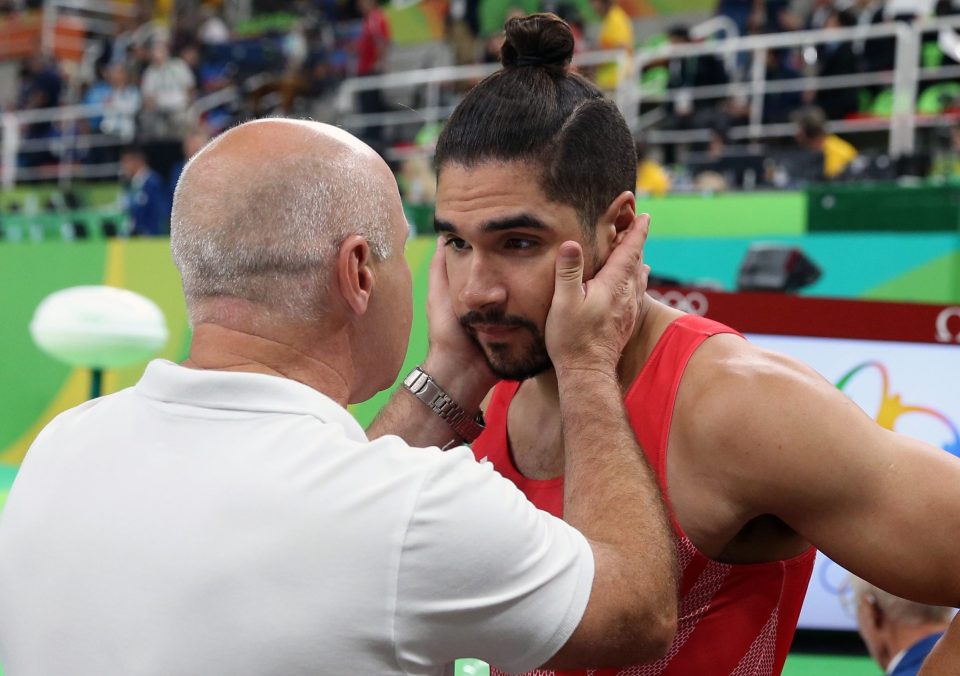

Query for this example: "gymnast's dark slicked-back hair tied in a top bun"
[435,14,637,231]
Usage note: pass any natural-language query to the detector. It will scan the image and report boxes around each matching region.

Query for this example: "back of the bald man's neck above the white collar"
[183,323,352,406]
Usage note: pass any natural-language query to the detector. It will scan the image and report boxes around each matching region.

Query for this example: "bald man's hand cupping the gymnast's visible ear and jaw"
[545,214,650,375]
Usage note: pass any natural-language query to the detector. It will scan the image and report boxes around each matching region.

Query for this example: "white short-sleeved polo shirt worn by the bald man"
[0,361,594,676]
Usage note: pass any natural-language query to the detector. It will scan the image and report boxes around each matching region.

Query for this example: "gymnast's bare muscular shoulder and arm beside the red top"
[684,337,960,606]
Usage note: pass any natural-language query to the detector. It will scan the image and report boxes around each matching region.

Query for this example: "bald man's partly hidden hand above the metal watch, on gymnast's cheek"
[424,239,497,392]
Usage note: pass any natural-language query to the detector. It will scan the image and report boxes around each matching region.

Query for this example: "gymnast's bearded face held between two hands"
[435,161,597,380]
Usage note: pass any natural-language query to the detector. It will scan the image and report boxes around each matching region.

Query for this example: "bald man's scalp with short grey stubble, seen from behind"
[170,119,402,322]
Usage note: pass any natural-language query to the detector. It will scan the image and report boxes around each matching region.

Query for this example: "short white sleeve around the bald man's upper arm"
[394,448,594,673]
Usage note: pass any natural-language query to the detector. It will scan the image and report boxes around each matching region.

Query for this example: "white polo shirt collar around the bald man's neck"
[135,359,367,442]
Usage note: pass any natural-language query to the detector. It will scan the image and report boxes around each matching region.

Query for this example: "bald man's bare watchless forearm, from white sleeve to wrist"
[547,364,677,668]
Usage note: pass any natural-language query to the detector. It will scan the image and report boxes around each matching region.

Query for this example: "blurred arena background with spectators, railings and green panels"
[0,0,960,675]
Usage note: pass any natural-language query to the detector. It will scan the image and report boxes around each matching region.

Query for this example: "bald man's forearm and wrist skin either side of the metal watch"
[367,356,492,448]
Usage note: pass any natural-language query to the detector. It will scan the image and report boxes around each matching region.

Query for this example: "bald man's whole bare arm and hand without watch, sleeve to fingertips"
[546,216,677,668]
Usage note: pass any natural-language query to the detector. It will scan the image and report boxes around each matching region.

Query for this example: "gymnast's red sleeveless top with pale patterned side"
[473,315,816,676]
